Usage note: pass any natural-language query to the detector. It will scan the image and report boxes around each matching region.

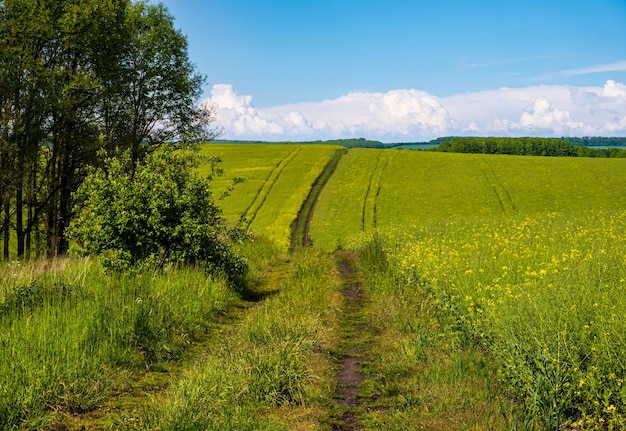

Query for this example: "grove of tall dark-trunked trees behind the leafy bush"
[0,0,214,258]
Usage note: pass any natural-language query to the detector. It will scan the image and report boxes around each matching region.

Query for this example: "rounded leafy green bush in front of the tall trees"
[67,145,247,281]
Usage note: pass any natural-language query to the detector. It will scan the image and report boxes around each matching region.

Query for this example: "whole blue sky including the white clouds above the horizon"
[153,0,626,142]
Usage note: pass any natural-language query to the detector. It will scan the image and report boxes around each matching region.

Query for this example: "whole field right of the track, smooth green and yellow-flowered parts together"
[311,150,626,429]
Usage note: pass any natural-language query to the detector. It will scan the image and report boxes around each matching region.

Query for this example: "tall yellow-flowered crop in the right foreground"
[354,211,626,430]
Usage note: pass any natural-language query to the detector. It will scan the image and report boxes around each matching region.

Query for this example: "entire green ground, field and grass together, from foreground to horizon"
[0,144,626,431]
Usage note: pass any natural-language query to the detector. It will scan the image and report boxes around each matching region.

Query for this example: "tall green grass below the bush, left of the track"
[0,259,237,429]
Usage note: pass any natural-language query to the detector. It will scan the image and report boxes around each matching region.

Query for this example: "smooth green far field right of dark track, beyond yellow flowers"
[310,149,626,251]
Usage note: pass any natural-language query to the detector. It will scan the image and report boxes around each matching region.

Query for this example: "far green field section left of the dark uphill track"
[202,144,341,250]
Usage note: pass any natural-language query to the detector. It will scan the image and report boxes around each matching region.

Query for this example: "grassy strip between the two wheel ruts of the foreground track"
[123,250,340,430]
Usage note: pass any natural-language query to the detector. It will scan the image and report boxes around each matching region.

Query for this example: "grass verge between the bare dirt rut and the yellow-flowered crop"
[358,236,521,431]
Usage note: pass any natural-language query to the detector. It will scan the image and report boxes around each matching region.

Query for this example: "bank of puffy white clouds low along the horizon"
[203,80,626,142]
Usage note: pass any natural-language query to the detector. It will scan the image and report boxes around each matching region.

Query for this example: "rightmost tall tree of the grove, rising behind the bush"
[103,2,216,165]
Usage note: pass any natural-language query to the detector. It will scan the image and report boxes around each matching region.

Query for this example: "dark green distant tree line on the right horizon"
[432,137,626,157]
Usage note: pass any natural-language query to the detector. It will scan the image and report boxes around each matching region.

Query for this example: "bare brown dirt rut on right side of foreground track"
[333,252,367,431]
